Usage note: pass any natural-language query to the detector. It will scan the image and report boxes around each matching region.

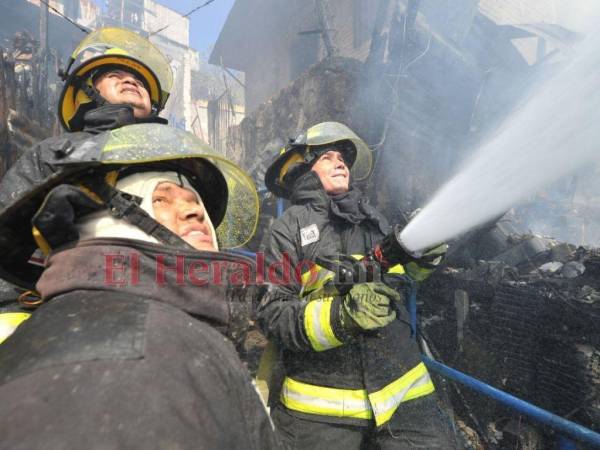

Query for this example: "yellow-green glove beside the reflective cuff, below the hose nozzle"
[340,283,401,332]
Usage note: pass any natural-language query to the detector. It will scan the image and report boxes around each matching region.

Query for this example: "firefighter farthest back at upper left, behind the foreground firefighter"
[0,28,173,344]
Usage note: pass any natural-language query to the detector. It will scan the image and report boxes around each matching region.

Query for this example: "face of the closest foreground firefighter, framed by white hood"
[152,182,217,251]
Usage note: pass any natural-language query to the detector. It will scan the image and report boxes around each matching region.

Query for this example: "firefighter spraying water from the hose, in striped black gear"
[258,122,455,450]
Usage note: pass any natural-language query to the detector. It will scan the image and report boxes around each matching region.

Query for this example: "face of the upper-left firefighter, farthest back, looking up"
[94,70,152,119]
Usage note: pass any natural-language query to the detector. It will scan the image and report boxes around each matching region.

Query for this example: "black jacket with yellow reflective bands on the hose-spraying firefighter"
[258,172,434,426]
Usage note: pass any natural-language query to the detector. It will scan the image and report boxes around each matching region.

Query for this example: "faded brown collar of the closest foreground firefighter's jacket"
[36,238,254,325]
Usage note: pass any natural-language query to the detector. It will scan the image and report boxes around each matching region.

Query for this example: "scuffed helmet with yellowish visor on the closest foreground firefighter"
[0,124,259,288]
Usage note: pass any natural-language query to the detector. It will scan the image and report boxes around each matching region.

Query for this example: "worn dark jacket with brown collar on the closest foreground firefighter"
[0,239,280,450]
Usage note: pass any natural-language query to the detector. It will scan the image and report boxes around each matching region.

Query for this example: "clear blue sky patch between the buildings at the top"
[94,0,235,55]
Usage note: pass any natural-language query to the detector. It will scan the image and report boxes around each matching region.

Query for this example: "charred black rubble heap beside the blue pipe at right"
[419,222,600,448]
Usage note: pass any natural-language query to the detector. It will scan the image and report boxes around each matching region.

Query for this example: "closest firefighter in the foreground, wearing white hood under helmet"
[0,124,279,450]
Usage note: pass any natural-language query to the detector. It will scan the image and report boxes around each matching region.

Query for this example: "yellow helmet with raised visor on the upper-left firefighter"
[58,28,173,131]
